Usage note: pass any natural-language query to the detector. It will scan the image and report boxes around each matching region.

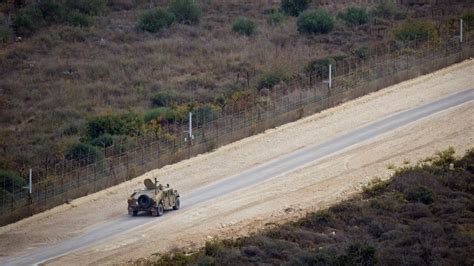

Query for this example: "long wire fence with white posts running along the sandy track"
[0,36,474,225]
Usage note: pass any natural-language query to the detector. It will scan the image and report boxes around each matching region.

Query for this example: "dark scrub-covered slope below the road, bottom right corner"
[140,149,474,265]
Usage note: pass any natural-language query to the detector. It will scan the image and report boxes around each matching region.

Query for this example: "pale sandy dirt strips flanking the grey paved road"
[0,60,474,264]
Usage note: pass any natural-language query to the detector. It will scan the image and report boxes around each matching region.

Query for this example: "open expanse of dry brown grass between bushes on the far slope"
[0,0,467,169]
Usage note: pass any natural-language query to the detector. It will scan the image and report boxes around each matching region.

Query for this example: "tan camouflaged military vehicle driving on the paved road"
[128,178,180,216]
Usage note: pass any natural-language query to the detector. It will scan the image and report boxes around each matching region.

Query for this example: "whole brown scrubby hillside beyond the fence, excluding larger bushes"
[0,0,472,178]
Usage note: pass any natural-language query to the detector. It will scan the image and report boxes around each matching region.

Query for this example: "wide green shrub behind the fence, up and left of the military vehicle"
[86,113,143,139]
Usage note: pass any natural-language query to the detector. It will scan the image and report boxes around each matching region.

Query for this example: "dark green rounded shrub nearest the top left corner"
[13,6,44,35]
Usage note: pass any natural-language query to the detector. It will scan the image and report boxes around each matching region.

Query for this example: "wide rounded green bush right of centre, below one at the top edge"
[296,10,334,34]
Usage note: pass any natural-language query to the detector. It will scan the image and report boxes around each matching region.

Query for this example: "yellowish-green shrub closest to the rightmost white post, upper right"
[392,21,437,43]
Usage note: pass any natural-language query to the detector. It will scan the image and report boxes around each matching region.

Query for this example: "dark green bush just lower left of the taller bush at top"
[137,9,175,33]
